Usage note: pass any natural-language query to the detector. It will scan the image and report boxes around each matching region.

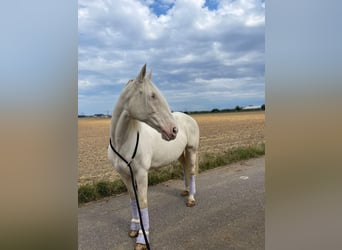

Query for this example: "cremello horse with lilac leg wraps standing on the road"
[108,65,199,249]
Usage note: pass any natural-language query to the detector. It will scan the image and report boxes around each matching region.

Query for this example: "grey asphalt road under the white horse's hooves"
[78,157,265,250]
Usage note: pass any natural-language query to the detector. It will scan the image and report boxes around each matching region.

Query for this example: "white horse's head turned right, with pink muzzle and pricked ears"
[127,64,178,141]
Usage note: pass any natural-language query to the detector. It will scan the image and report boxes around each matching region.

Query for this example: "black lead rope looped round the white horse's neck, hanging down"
[109,131,150,250]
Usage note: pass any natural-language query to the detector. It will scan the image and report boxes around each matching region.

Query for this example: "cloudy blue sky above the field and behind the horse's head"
[78,0,265,115]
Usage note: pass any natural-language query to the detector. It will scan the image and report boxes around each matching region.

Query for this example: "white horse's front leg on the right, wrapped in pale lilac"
[135,169,150,250]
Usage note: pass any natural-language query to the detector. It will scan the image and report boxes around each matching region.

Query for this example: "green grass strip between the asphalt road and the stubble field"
[78,144,265,204]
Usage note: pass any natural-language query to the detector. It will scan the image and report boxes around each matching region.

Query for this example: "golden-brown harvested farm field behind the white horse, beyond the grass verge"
[78,111,265,186]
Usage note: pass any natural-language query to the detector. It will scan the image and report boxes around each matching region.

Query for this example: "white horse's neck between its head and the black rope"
[110,99,138,150]
